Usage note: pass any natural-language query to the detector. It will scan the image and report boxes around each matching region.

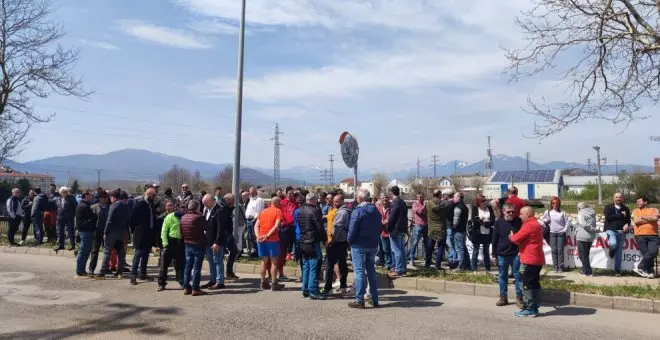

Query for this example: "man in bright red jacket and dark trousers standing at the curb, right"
[509,206,545,317]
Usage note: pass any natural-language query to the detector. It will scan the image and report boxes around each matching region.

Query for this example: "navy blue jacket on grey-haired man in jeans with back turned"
[348,202,381,250]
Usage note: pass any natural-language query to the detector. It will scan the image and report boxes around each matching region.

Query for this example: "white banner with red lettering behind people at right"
[467,223,642,271]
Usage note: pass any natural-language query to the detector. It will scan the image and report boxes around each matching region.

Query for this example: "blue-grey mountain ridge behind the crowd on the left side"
[6,149,273,184]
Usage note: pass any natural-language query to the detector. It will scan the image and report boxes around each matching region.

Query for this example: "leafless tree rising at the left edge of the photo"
[0,0,90,161]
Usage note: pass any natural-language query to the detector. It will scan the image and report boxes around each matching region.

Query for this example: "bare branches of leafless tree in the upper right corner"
[506,0,660,137]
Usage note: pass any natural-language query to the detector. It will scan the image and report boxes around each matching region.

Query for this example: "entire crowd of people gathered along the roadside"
[7,184,658,316]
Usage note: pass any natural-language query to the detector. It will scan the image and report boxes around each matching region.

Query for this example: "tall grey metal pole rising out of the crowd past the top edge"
[231,0,245,228]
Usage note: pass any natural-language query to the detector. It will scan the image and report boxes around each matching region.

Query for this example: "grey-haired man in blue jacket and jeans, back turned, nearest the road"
[348,189,381,309]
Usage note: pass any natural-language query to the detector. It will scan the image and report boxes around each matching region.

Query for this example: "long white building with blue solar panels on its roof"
[483,170,563,199]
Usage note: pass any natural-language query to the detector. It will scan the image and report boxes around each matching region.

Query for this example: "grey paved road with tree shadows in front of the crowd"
[0,254,660,340]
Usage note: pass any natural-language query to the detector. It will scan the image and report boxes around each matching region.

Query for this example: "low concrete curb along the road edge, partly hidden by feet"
[0,246,660,313]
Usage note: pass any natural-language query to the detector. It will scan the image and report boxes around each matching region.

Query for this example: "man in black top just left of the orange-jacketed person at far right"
[603,192,632,276]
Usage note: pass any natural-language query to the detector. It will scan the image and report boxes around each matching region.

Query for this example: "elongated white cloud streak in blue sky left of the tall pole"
[119,20,211,50]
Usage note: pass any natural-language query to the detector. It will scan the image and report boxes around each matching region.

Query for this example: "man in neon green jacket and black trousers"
[158,201,187,292]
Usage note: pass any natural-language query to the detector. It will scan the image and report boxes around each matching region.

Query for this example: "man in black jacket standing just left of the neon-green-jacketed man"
[130,187,156,285]
